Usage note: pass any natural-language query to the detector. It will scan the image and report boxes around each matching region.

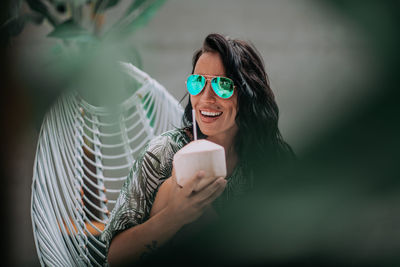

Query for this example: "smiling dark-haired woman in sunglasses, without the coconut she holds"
[102,34,292,265]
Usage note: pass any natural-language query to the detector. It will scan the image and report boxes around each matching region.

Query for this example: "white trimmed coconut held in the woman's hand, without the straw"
[173,139,226,188]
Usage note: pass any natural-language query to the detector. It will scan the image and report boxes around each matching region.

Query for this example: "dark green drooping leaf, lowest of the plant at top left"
[47,19,98,42]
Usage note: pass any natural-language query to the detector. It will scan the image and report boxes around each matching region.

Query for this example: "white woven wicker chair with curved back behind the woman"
[31,63,183,266]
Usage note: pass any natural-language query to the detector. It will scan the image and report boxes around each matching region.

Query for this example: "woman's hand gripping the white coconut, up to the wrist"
[162,171,227,226]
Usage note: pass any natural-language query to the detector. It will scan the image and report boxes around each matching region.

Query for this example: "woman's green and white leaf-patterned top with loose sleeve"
[100,129,251,252]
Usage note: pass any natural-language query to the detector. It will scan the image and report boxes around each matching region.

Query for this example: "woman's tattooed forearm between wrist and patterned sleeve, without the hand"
[108,209,183,266]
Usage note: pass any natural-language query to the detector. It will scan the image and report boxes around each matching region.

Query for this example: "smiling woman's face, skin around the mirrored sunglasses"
[190,52,238,141]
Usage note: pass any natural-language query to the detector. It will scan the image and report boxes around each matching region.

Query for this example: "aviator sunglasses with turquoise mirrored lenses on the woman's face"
[186,74,235,99]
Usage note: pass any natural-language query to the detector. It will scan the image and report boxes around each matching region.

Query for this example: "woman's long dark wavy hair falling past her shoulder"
[183,33,294,171]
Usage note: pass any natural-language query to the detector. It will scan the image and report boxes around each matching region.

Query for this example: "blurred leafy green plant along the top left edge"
[1,0,165,43]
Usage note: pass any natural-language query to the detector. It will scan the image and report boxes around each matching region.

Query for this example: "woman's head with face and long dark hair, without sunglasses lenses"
[183,34,293,172]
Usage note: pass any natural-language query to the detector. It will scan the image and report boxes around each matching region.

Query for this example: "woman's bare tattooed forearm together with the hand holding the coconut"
[108,172,226,265]
